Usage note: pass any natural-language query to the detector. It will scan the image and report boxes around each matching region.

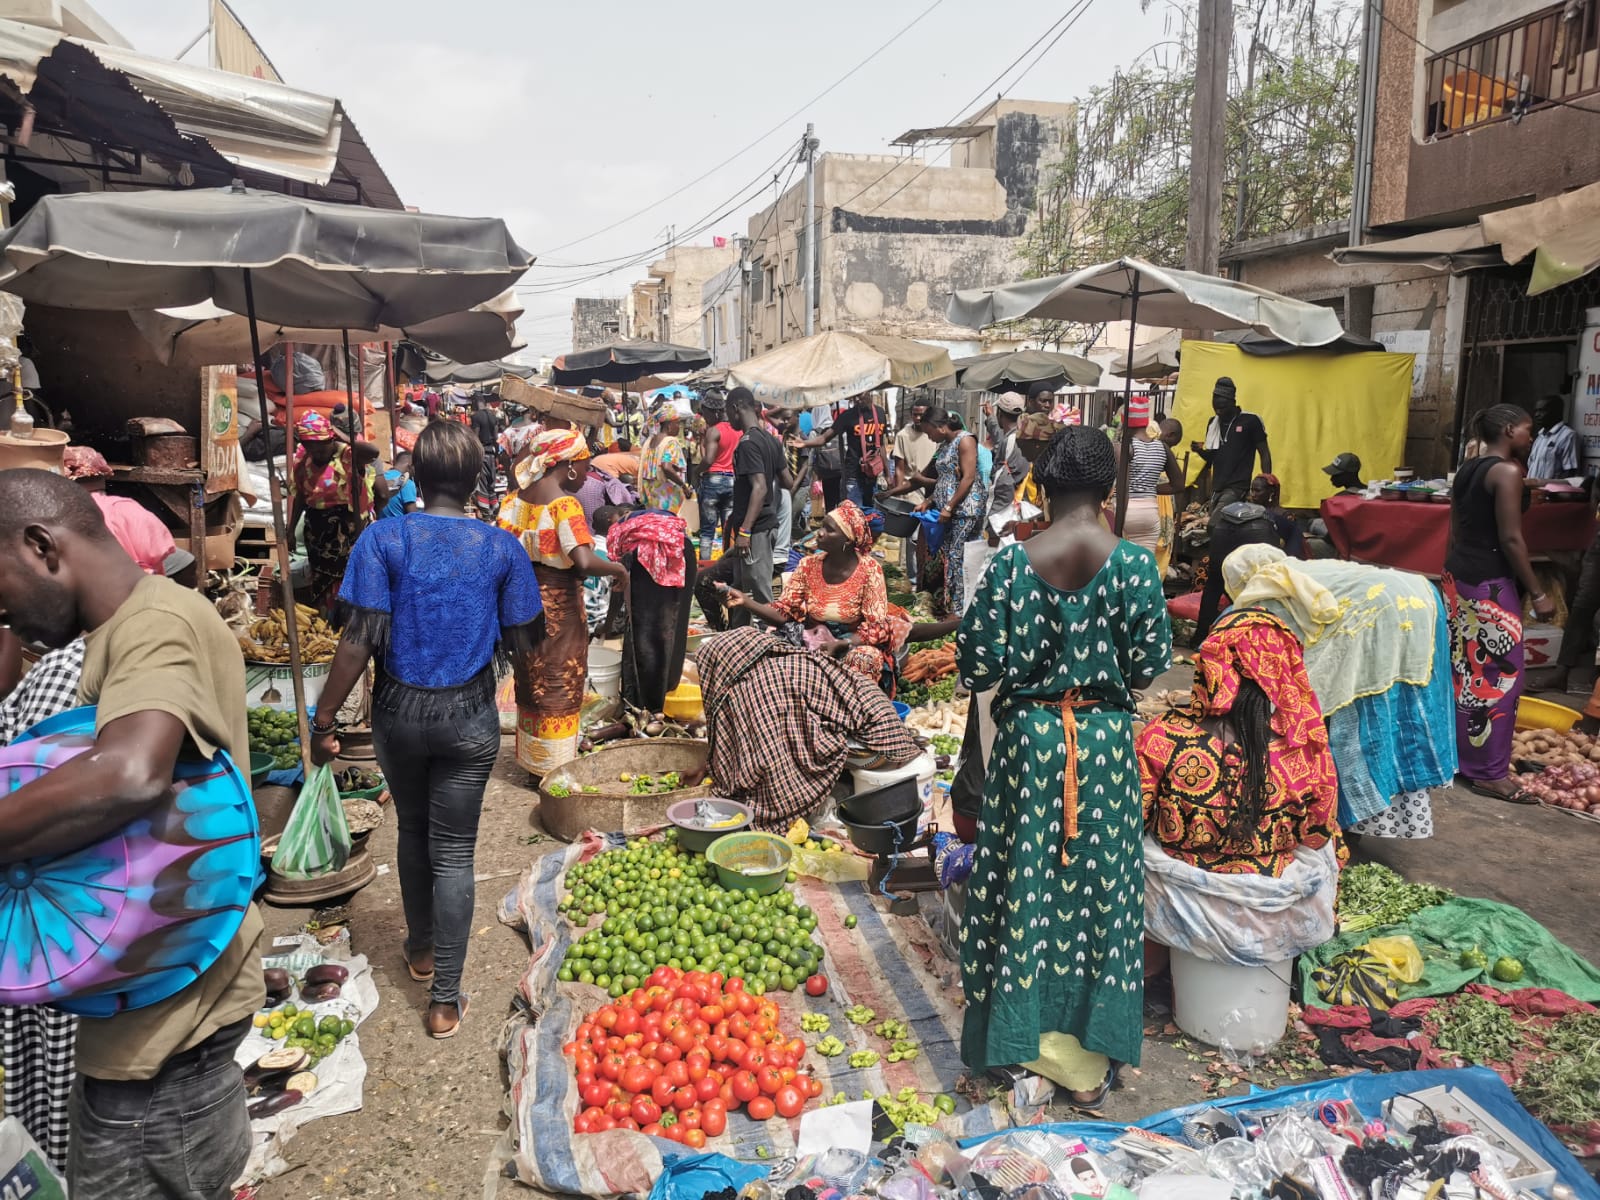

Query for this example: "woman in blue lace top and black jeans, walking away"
[312,421,544,1038]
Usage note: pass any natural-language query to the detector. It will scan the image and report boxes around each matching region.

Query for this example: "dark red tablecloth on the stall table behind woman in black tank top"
[1322,496,1595,576]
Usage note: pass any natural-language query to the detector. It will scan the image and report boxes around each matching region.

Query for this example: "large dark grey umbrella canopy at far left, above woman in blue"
[0,187,533,330]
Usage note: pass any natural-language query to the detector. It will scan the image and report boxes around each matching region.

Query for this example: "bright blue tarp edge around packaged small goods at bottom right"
[962,1067,1600,1200]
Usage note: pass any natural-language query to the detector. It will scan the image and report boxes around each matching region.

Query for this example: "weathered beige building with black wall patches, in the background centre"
[736,101,1074,355]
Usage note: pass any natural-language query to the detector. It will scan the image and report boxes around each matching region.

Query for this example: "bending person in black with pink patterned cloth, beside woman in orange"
[606,508,696,712]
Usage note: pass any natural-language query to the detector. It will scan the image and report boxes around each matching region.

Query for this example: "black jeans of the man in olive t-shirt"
[67,1021,250,1200]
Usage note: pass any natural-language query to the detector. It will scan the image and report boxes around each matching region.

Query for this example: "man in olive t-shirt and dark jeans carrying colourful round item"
[0,470,266,1200]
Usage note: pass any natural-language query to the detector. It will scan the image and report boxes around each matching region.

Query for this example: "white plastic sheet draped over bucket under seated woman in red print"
[1144,837,1339,966]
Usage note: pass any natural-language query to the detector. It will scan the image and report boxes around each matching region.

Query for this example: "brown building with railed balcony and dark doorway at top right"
[1224,0,1600,475]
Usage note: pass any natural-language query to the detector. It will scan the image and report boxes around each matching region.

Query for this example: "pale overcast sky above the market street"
[91,0,1168,354]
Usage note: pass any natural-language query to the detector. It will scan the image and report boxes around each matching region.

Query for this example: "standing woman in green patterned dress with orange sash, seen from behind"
[957,426,1171,1109]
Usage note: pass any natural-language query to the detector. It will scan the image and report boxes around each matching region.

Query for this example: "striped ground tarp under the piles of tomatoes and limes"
[501,834,1010,1197]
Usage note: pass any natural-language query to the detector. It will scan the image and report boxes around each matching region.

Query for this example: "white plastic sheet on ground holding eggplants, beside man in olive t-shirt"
[234,934,378,1179]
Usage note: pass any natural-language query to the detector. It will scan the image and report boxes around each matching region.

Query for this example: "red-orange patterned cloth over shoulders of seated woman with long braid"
[1192,608,1328,749]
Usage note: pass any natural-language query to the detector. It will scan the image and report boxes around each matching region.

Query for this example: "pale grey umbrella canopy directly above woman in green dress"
[947,258,1344,346]
